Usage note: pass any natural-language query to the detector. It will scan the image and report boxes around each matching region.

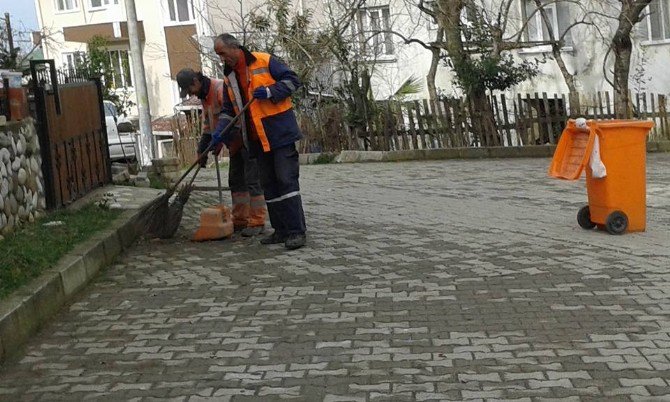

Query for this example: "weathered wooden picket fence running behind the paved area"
[302,92,670,152]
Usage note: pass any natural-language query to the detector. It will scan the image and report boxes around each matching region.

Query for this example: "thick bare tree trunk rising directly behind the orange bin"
[611,0,651,119]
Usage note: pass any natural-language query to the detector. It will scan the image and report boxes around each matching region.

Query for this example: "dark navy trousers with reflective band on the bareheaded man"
[258,143,307,236]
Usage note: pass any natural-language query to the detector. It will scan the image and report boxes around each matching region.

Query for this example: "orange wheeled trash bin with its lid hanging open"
[549,120,654,234]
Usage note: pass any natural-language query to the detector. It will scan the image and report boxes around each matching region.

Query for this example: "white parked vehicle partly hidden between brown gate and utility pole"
[103,101,137,161]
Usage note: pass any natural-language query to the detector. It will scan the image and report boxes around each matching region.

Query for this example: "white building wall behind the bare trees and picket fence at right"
[344,0,670,99]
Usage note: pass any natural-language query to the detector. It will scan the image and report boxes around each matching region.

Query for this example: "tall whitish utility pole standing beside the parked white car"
[125,0,156,166]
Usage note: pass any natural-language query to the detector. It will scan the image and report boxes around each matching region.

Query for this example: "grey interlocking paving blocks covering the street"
[0,155,670,401]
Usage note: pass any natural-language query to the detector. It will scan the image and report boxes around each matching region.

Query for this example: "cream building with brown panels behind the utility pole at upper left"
[34,0,211,118]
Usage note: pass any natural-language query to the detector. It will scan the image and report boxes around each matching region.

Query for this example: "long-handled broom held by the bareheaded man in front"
[136,98,254,239]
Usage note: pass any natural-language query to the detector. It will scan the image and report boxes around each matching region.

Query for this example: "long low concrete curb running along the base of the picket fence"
[300,141,670,165]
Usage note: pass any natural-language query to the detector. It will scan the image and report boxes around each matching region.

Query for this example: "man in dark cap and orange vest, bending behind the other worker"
[176,68,267,237]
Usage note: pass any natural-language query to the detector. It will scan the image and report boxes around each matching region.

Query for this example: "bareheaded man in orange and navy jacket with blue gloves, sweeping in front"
[212,34,307,250]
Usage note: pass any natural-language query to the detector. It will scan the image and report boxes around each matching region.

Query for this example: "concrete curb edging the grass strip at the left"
[0,210,140,363]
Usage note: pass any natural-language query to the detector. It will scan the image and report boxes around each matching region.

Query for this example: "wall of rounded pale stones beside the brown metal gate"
[0,118,46,237]
